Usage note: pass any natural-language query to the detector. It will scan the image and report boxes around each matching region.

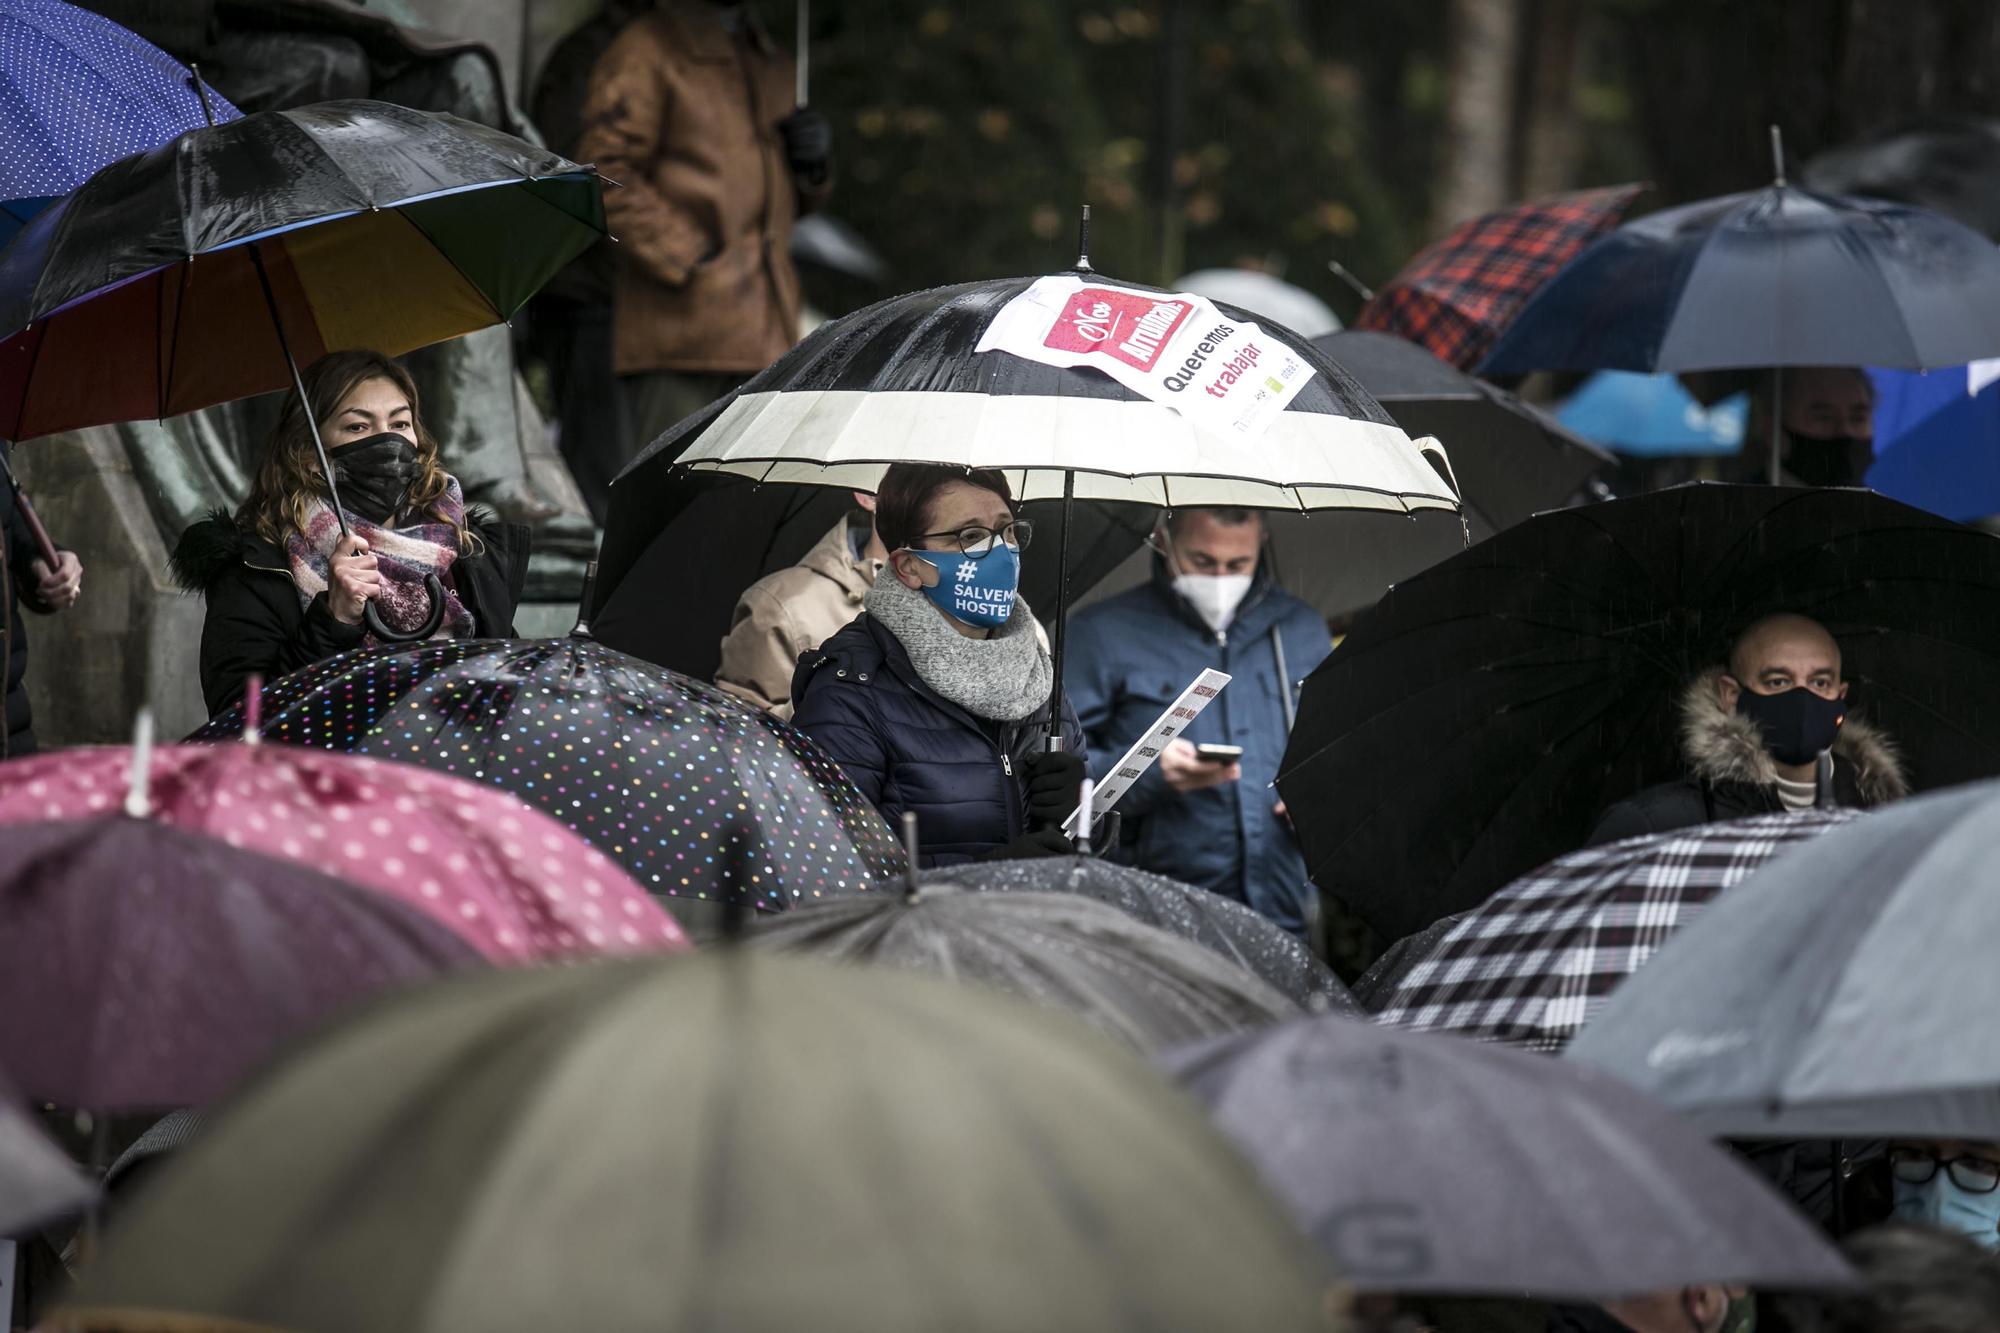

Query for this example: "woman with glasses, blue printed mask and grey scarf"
[792,462,1086,865]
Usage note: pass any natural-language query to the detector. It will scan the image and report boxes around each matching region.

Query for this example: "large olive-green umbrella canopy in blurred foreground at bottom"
[70,951,1326,1333]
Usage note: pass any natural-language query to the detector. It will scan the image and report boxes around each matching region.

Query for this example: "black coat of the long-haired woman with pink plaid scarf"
[174,510,530,717]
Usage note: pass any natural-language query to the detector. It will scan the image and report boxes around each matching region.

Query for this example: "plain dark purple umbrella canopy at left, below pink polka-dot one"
[0,815,480,1111]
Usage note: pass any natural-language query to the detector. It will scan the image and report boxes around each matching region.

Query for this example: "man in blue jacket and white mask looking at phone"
[1064,508,1332,931]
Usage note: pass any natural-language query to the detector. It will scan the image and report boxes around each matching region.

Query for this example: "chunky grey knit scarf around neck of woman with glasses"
[862,564,1056,723]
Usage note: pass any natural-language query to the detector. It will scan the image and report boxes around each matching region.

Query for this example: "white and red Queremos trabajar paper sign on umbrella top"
[974,274,1314,438]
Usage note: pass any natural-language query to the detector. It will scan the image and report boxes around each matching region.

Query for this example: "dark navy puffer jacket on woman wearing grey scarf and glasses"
[792,612,1082,867]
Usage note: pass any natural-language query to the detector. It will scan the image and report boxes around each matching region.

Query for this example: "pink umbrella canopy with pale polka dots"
[0,745,688,963]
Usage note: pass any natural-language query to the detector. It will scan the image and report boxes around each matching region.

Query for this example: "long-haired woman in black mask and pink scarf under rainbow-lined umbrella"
[174,352,528,713]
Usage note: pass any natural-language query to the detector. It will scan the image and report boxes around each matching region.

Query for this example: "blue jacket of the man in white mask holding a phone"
[1062,558,1332,931]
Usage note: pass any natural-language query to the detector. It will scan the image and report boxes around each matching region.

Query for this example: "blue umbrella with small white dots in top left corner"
[0,0,242,244]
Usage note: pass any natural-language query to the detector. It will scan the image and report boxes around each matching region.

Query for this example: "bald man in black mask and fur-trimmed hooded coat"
[1590,614,1910,847]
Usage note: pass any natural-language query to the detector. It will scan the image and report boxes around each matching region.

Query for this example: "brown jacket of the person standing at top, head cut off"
[576,0,824,374]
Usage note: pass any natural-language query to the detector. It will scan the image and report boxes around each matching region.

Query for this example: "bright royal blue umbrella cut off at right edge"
[1868,360,2000,522]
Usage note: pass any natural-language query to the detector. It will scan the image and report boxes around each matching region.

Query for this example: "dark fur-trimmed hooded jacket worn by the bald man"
[1586,667,1910,847]
